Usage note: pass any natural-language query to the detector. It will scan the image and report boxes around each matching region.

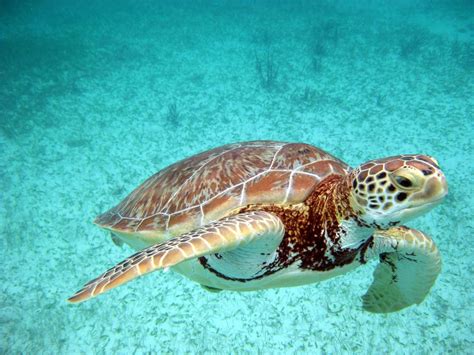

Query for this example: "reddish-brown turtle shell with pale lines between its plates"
[95,141,350,236]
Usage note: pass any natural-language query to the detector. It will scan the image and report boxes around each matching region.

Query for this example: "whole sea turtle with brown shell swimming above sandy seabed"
[69,141,448,313]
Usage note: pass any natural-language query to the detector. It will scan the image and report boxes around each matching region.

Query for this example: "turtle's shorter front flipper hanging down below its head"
[362,227,441,313]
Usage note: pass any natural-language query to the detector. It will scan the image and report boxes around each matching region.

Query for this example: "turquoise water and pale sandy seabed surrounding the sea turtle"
[0,0,474,354]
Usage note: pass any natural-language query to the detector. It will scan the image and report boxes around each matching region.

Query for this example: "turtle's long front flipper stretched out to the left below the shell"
[68,211,284,302]
